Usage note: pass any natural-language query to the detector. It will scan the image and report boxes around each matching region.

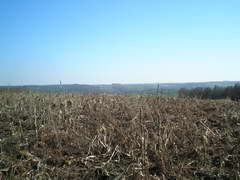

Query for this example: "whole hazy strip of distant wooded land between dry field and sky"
[0,81,240,100]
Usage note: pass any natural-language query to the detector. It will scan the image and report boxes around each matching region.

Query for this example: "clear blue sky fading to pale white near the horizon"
[0,0,240,85]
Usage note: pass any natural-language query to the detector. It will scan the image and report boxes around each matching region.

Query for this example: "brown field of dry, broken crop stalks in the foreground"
[0,92,240,180]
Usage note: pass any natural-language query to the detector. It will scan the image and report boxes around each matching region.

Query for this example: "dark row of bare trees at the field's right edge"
[178,84,240,101]
